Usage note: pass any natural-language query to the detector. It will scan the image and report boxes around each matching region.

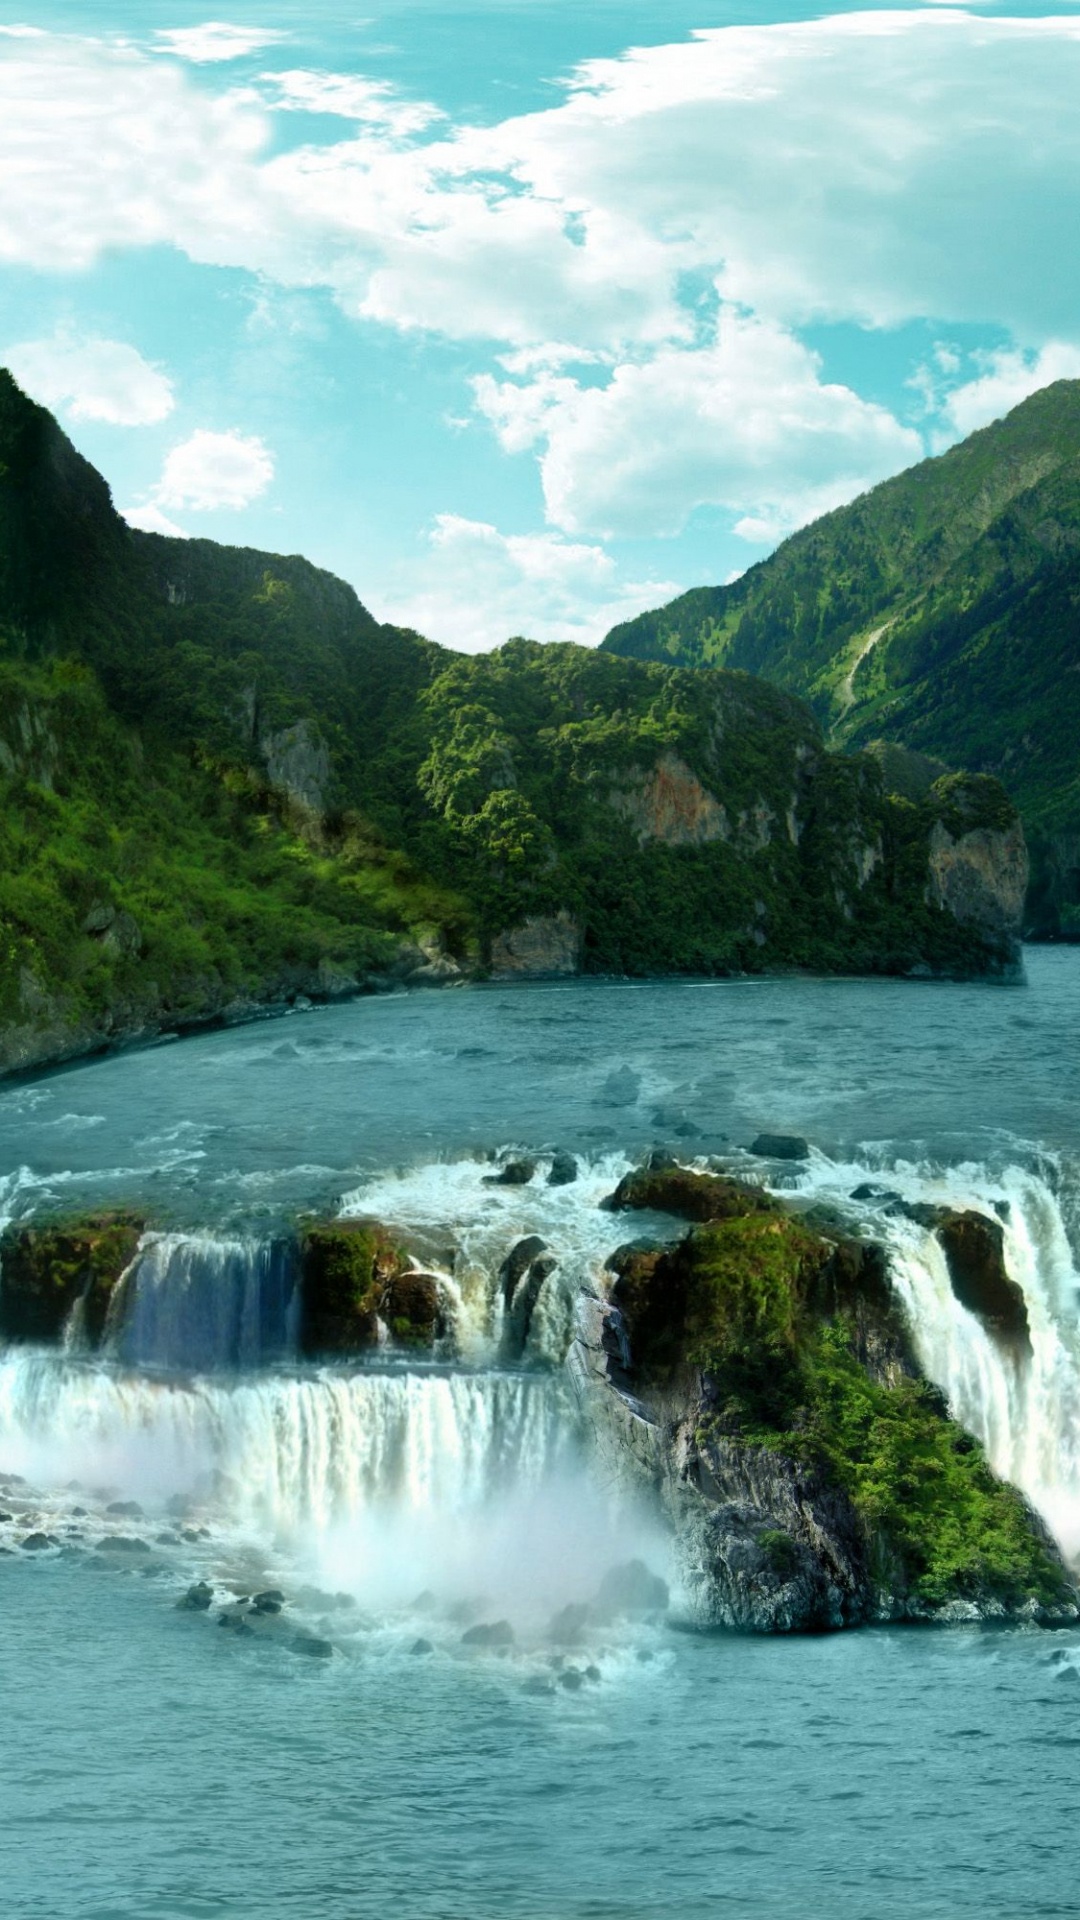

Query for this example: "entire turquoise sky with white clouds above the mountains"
[0,0,1080,651]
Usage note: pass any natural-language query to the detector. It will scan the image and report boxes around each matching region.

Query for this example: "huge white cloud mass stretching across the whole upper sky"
[0,6,1080,540]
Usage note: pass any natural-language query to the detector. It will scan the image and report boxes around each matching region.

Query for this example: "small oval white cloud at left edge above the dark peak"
[0,330,175,426]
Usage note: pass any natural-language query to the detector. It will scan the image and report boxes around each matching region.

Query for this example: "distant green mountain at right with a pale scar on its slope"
[603,380,1080,935]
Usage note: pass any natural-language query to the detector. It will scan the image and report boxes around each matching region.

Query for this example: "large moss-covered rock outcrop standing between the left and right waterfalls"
[582,1162,1078,1632]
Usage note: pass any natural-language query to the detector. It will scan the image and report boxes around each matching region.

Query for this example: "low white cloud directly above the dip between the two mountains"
[384,513,682,653]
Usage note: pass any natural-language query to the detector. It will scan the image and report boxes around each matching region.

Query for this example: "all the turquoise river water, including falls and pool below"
[0,950,1080,1920]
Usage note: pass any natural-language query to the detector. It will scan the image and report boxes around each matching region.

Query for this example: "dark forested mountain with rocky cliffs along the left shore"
[0,374,1026,1069]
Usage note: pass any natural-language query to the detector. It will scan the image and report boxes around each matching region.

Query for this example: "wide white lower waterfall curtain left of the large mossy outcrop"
[0,1350,578,1530]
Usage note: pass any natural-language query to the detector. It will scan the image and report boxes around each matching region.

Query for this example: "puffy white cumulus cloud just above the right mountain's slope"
[477,307,922,543]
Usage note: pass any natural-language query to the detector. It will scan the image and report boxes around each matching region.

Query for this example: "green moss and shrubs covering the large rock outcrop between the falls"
[615,1213,1065,1607]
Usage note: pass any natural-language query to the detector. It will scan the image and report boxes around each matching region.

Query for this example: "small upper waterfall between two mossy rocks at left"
[106,1235,300,1373]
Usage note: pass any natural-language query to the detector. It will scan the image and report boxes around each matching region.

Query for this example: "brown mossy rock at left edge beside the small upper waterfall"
[0,1212,146,1346]
